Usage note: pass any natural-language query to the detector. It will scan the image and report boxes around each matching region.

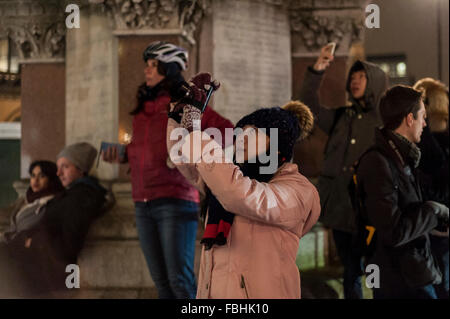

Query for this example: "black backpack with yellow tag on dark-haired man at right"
[348,145,399,264]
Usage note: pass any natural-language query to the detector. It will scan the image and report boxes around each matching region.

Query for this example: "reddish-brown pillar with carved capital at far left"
[0,0,65,178]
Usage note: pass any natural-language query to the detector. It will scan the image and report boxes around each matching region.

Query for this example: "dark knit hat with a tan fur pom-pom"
[236,101,314,165]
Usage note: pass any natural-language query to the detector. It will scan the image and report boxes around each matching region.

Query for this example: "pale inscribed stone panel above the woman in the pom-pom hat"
[210,0,291,123]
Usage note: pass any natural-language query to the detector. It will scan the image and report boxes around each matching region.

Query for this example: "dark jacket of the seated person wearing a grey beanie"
[4,177,107,293]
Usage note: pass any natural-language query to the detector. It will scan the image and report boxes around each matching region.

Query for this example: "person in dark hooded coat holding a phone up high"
[300,45,387,299]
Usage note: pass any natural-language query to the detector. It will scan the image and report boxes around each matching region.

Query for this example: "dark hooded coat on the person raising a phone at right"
[300,61,387,232]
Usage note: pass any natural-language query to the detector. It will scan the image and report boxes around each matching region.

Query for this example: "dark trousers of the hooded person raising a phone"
[333,229,363,299]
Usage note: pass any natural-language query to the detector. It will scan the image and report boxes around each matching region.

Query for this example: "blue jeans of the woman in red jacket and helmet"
[135,198,198,299]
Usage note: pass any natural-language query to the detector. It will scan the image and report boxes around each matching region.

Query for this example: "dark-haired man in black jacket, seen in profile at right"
[356,86,449,299]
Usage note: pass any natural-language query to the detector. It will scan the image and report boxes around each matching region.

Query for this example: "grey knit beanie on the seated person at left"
[56,142,97,173]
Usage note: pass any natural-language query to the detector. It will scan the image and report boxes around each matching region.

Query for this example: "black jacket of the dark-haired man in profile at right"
[357,129,441,289]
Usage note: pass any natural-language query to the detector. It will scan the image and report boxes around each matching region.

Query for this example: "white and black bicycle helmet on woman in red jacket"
[143,41,188,70]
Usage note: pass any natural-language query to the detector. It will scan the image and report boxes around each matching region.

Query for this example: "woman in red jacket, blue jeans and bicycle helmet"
[103,42,233,298]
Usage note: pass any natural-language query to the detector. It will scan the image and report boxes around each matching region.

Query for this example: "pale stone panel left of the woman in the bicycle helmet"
[65,3,119,180]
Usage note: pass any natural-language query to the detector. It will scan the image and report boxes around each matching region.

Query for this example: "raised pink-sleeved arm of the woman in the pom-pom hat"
[183,131,320,233]
